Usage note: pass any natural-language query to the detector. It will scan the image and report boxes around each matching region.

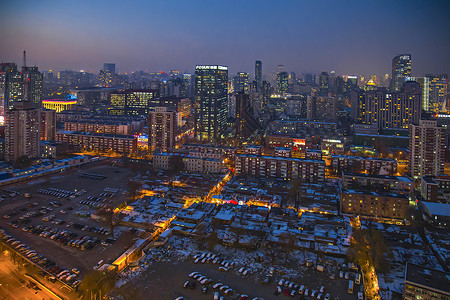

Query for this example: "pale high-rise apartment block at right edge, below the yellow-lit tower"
[409,120,447,178]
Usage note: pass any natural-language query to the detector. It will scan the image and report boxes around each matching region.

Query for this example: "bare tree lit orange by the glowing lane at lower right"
[347,229,388,271]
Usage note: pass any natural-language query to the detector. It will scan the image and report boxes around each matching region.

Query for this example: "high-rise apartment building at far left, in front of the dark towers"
[5,103,41,162]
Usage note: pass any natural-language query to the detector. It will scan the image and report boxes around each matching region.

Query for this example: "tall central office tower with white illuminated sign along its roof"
[194,65,228,141]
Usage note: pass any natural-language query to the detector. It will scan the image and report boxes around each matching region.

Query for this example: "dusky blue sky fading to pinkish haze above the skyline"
[0,0,450,76]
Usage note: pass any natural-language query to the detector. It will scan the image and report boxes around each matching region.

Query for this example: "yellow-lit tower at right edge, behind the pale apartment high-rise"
[425,74,448,113]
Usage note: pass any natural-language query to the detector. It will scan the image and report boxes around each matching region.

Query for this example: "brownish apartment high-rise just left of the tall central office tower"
[148,107,177,151]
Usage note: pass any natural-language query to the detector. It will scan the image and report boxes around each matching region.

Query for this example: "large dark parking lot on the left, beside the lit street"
[0,165,139,284]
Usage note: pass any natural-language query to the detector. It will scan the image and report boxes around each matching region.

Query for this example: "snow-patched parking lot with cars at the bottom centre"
[115,236,362,300]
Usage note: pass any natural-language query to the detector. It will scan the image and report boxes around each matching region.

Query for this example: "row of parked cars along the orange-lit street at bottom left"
[0,229,81,287]
